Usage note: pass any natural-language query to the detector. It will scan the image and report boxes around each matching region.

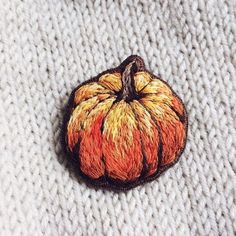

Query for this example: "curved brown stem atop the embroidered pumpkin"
[120,57,144,101]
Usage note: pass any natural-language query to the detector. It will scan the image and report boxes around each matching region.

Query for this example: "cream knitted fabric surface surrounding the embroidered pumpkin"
[0,0,236,236]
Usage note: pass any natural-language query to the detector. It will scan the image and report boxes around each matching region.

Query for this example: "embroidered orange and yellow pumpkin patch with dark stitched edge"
[65,56,187,189]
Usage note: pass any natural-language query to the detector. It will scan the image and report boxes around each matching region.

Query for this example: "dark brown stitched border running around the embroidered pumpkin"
[61,55,188,191]
